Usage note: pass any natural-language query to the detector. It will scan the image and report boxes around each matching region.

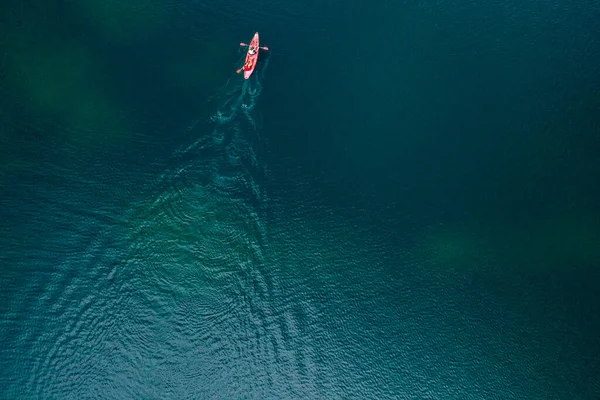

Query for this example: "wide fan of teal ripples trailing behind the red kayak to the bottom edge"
[2,51,324,398]
